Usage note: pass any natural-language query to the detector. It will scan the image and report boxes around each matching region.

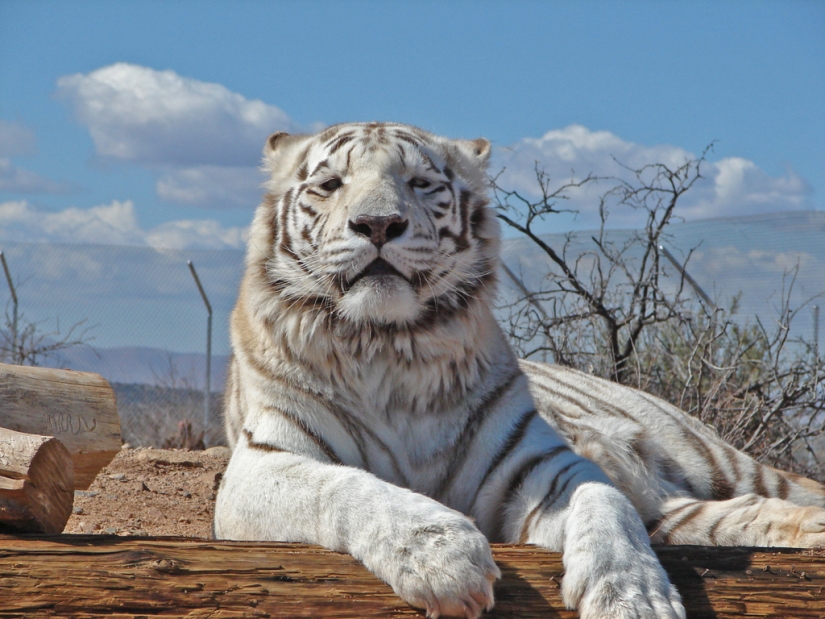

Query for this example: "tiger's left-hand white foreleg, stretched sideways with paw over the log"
[215,443,500,618]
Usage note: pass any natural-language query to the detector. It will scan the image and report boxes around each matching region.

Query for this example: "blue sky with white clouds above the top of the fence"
[0,0,825,248]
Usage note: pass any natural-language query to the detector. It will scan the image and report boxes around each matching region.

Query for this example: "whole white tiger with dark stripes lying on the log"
[214,123,825,619]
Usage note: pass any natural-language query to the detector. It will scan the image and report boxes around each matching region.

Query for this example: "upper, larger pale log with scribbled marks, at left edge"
[0,363,121,490]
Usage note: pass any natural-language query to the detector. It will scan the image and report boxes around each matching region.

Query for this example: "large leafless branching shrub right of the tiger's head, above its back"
[492,154,825,479]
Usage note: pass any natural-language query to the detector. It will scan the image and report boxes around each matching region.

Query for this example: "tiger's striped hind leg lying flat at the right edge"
[650,494,825,548]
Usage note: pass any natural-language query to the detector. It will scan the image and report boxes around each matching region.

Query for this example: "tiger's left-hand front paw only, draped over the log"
[375,517,501,619]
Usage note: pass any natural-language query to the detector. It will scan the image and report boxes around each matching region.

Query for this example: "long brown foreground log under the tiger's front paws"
[0,535,825,619]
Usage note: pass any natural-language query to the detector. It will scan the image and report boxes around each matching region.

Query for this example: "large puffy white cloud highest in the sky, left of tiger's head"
[57,63,308,208]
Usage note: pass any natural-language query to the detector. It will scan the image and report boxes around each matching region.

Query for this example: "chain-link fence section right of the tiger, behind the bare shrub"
[501,211,825,349]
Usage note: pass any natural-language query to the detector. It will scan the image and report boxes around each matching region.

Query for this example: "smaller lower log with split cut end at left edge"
[0,428,74,533]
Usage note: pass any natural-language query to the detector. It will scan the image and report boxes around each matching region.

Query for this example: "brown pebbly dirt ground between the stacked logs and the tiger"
[63,447,230,538]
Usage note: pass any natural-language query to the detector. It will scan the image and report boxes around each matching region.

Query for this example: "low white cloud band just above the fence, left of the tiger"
[0,200,247,249]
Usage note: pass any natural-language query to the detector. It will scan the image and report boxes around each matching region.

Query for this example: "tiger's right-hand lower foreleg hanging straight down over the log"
[511,459,685,619]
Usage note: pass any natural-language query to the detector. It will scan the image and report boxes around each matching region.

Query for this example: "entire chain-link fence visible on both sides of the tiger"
[0,212,825,446]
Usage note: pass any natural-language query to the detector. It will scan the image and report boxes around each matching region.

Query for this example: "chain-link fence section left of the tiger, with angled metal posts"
[0,243,243,446]
